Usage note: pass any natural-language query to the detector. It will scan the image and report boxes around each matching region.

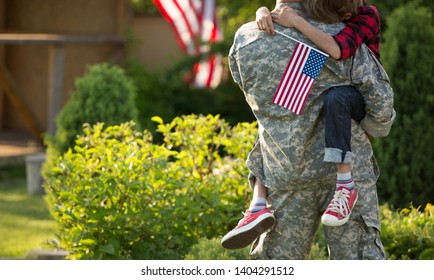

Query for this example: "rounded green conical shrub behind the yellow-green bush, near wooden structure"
[43,63,138,182]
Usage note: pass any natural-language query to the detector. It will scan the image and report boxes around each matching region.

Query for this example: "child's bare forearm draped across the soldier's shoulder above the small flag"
[271,7,341,59]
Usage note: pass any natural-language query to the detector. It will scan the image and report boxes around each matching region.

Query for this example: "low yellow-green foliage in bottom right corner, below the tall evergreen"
[380,204,434,260]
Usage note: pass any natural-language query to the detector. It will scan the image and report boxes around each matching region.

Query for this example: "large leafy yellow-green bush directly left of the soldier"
[45,115,256,259]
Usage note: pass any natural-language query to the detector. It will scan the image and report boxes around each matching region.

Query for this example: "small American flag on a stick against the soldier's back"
[273,38,328,115]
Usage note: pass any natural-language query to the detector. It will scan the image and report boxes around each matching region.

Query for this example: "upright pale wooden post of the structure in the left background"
[47,44,65,136]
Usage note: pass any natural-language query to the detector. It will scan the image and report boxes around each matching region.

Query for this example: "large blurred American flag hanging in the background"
[152,0,223,88]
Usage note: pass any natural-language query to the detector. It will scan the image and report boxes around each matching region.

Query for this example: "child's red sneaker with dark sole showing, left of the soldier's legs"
[221,208,275,249]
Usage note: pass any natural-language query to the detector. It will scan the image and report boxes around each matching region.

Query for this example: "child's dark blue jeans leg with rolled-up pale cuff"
[324,86,365,163]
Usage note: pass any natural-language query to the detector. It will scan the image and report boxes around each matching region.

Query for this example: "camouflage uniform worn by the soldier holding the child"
[229,3,395,259]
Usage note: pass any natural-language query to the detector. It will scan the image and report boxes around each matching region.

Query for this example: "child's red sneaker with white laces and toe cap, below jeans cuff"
[321,187,357,227]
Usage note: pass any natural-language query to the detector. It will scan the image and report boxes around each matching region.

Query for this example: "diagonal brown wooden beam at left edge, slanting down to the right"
[0,64,43,144]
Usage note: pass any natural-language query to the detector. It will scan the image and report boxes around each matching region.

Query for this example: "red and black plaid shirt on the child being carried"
[333,1,380,60]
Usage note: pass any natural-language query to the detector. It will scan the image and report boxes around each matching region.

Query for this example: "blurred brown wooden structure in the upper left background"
[0,0,131,143]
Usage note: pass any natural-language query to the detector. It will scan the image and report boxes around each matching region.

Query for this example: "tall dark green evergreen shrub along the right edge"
[374,3,434,207]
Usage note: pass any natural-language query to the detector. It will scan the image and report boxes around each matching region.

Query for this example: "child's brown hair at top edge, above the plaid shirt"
[303,0,363,23]
